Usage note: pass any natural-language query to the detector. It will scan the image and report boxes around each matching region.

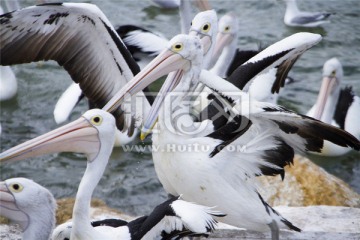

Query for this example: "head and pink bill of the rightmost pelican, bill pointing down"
[314,58,343,121]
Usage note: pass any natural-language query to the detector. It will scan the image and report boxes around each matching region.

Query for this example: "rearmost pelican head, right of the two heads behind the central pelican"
[211,12,239,61]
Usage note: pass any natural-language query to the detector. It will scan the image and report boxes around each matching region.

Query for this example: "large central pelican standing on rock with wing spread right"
[104,33,360,239]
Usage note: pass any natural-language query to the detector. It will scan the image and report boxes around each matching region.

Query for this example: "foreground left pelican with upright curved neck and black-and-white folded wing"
[0,109,223,239]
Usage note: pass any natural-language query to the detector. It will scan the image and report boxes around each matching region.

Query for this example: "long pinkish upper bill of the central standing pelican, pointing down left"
[103,49,190,112]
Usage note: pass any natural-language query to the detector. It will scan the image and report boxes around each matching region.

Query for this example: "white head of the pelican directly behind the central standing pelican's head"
[189,10,218,65]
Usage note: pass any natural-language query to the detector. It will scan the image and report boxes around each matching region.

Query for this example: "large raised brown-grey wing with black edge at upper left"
[0,3,148,131]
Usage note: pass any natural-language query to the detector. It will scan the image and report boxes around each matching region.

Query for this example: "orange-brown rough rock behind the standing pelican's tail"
[258,156,360,207]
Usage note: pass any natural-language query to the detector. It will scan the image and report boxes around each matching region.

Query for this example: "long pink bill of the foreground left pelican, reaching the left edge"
[0,117,100,162]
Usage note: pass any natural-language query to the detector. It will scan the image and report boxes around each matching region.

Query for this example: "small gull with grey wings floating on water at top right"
[284,0,331,27]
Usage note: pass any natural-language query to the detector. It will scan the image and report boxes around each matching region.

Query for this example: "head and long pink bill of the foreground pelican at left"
[0,109,116,162]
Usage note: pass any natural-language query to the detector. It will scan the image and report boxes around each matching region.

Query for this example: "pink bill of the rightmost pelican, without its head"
[314,77,337,120]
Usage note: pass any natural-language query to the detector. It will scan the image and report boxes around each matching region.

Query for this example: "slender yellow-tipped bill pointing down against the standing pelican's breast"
[140,70,184,141]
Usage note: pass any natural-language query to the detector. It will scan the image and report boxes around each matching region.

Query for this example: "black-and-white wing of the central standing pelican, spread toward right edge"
[207,100,360,178]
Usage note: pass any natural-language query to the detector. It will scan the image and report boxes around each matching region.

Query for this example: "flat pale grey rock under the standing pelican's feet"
[208,206,360,240]
